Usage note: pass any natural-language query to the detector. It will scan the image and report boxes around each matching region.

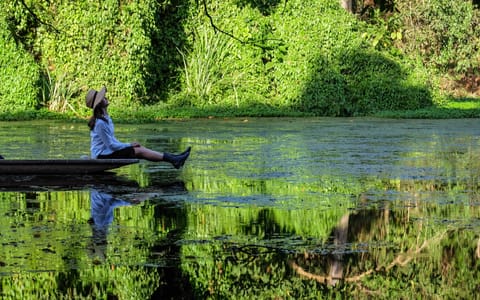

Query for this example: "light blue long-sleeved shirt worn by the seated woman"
[90,116,131,158]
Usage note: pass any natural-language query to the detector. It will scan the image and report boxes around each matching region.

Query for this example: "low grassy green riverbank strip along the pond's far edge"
[0,98,480,123]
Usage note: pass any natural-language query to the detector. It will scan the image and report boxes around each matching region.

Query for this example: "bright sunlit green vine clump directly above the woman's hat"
[41,1,149,107]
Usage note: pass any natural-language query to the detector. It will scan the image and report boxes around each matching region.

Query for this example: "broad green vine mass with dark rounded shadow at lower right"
[174,1,432,116]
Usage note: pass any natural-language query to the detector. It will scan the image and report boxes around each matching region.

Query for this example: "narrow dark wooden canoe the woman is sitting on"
[0,159,139,175]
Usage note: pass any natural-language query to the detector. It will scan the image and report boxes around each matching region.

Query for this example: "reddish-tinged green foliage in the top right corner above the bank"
[397,0,480,74]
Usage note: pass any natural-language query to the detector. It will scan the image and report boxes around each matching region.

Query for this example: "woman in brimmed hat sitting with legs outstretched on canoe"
[86,87,190,169]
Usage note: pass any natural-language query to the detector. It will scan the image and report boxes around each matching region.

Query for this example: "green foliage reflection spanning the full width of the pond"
[0,139,480,299]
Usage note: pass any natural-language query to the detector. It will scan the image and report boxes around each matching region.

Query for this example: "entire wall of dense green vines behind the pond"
[0,0,480,116]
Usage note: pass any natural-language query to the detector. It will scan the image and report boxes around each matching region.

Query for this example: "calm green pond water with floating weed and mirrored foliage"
[0,118,480,299]
